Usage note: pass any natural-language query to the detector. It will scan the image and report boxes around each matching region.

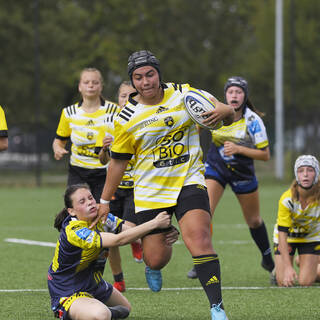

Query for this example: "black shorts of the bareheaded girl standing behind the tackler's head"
[68,164,107,203]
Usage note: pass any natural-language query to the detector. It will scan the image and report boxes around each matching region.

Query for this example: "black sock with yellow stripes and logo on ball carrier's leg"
[192,254,223,309]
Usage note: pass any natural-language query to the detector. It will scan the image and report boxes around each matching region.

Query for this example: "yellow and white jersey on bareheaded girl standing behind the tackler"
[56,100,120,169]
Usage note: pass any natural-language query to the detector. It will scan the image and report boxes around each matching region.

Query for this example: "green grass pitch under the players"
[0,183,320,320]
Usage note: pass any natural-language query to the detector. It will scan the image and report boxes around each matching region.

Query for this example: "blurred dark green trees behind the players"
[0,0,320,158]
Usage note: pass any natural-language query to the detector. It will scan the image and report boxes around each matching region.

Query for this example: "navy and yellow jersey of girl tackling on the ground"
[48,214,123,297]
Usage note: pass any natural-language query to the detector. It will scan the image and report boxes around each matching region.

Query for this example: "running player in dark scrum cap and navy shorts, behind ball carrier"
[188,77,274,278]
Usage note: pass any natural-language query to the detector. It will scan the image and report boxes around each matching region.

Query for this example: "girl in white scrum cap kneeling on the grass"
[271,155,320,287]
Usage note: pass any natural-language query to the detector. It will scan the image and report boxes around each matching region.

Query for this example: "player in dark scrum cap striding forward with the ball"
[96,50,233,319]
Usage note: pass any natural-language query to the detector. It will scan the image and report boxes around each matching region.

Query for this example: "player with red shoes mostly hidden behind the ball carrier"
[97,81,143,292]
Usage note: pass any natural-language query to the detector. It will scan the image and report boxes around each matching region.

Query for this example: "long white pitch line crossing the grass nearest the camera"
[0,286,320,293]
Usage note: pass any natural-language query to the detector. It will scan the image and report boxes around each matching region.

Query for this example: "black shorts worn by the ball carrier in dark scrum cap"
[136,184,210,234]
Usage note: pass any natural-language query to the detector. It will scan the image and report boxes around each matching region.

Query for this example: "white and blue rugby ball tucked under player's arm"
[183,89,223,130]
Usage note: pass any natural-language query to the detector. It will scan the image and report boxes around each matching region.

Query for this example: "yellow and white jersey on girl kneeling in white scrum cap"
[273,189,320,243]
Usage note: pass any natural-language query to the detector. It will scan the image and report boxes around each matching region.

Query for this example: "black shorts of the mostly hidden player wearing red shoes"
[109,188,137,224]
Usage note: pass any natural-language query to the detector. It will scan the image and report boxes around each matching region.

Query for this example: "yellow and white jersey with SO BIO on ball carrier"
[111,83,205,212]
